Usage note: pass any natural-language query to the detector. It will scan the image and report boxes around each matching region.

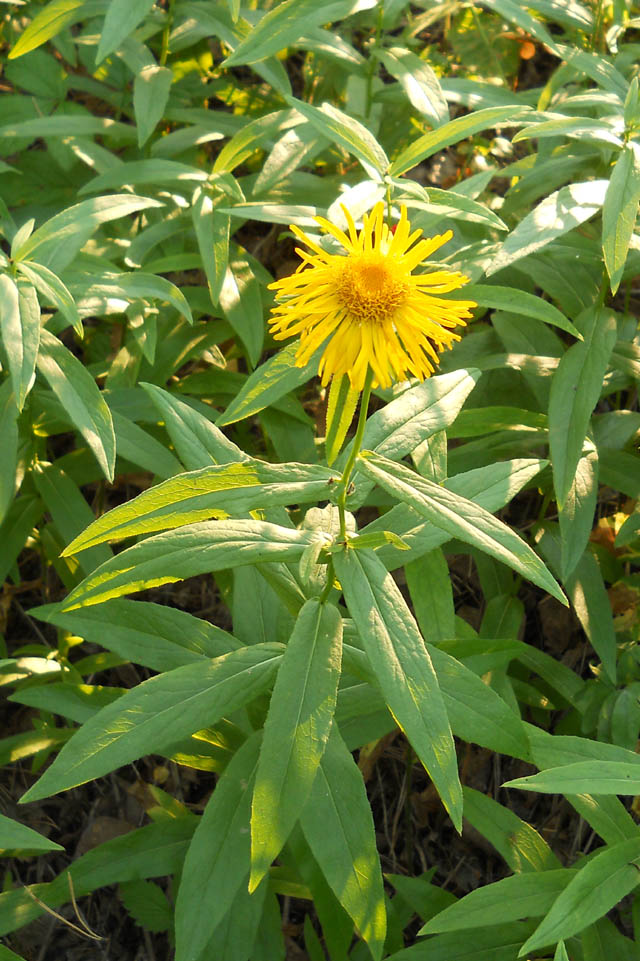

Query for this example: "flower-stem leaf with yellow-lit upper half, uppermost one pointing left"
[64,460,337,556]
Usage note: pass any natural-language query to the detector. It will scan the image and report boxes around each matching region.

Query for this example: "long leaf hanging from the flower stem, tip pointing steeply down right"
[333,550,462,830]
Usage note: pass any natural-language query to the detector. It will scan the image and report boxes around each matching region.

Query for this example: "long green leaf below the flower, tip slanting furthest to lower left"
[21,644,283,802]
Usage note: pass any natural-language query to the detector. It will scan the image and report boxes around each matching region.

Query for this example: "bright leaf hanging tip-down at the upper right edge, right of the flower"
[602,140,640,294]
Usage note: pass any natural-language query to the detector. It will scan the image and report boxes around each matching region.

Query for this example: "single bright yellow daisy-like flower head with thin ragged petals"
[269,201,476,391]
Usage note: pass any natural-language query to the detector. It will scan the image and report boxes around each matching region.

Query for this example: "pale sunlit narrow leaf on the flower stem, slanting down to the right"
[359,452,567,605]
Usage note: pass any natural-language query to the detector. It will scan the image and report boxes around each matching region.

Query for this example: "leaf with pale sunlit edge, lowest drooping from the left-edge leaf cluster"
[38,328,116,481]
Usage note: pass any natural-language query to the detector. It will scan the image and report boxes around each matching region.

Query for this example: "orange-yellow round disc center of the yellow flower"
[337,253,409,322]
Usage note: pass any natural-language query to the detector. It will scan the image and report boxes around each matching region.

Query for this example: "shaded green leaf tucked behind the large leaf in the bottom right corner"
[418,868,577,935]
